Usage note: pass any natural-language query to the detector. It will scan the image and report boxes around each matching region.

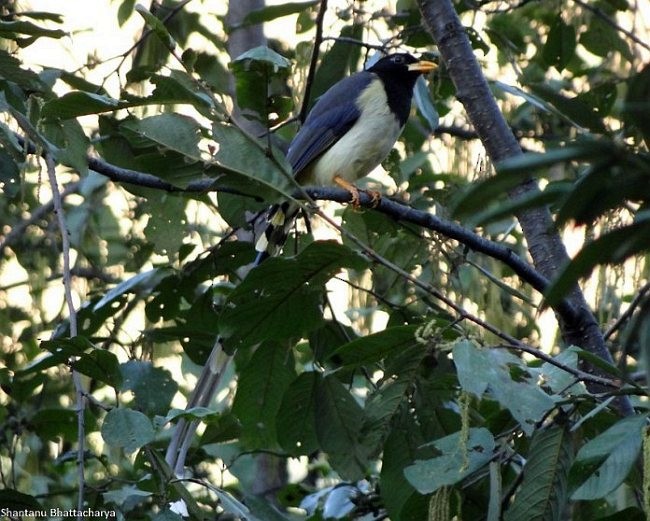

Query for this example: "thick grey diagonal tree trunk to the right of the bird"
[418,0,633,415]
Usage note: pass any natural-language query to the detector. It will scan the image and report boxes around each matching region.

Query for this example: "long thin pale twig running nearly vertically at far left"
[45,153,86,521]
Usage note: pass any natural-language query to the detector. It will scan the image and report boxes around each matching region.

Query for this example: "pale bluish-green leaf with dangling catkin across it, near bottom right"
[404,428,495,494]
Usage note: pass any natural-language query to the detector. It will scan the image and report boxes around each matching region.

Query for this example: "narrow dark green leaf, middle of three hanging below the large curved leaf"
[276,371,322,456]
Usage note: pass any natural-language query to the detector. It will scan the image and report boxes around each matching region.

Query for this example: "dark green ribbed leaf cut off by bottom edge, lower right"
[504,425,573,521]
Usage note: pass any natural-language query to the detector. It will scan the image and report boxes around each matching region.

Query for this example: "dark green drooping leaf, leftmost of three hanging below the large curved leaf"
[232,342,296,449]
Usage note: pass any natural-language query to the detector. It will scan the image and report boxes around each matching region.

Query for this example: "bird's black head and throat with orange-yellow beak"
[367,53,437,125]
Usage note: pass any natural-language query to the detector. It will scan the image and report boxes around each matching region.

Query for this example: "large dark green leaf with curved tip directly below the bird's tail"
[219,241,366,349]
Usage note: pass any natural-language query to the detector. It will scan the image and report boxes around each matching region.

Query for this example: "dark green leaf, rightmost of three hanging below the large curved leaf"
[315,375,367,481]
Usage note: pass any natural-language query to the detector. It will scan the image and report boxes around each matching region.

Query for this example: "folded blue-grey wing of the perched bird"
[287,71,374,176]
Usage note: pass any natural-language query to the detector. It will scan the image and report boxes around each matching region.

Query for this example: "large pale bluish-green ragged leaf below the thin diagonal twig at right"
[453,340,555,435]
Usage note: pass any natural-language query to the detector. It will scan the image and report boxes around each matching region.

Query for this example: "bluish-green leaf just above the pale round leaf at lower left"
[120,360,178,415]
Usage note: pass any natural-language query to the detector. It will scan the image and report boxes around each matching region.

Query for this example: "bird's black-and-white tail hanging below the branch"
[253,201,300,266]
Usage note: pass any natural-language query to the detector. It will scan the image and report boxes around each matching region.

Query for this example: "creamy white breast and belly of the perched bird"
[304,78,402,186]
